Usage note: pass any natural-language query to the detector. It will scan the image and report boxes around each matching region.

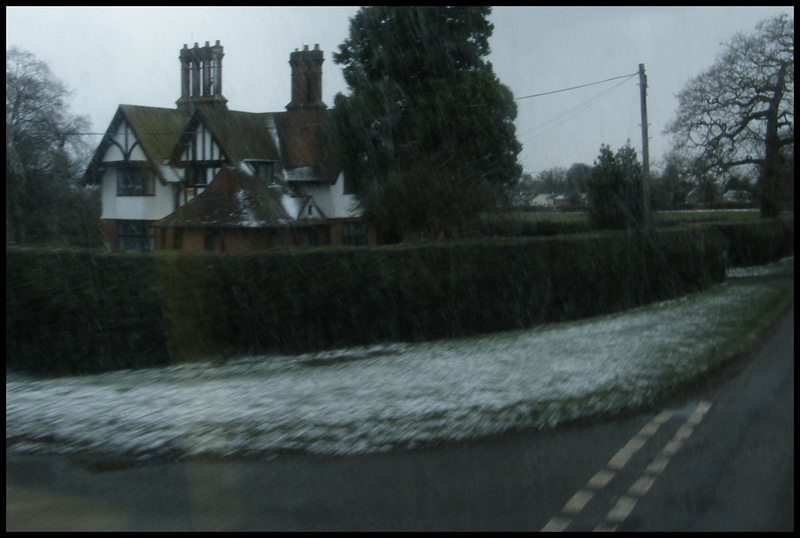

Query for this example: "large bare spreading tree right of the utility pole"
[666,14,794,218]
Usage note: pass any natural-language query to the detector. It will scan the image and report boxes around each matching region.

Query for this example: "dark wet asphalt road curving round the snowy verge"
[6,277,794,531]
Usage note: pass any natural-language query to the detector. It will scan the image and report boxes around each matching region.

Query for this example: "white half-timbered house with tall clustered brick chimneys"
[86,41,375,252]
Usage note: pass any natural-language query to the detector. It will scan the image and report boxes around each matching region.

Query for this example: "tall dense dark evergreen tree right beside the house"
[331,6,522,238]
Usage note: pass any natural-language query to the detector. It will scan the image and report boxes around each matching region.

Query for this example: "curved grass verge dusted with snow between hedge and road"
[6,284,783,459]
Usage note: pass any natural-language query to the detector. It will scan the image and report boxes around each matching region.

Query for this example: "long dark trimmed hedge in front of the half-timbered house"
[6,228,726,375]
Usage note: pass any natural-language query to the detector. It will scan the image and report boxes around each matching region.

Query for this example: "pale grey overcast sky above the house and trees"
[6,6,794,174]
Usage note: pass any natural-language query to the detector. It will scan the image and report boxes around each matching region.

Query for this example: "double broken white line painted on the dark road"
[542,402,711,532]
